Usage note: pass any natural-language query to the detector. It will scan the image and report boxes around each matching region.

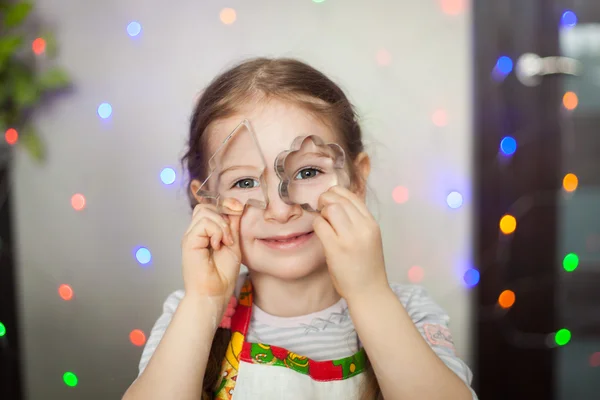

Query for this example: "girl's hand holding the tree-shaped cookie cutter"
[181,199,243,300]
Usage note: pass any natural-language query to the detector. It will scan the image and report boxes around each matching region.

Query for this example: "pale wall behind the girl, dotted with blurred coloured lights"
[14,0,472,400]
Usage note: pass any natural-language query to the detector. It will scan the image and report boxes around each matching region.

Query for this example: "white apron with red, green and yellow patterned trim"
[215,279,366,400]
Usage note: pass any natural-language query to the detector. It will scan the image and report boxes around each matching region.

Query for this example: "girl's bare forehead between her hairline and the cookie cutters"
[207,101,337,159]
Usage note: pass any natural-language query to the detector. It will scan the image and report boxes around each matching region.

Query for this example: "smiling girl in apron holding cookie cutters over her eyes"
[124,59,476,400]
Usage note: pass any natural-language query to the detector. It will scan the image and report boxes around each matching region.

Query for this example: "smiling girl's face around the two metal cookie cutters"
[198,100,338,279]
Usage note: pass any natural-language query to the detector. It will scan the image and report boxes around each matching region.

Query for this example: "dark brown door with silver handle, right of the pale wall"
[474,0,600,400]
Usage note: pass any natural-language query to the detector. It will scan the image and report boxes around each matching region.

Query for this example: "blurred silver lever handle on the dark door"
[515,53,582,86]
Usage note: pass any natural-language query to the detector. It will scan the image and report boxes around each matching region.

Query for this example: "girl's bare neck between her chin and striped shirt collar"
[250,267,340,317]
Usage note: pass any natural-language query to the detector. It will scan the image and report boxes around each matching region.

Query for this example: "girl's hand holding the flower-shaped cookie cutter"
[313,186,389,302]
